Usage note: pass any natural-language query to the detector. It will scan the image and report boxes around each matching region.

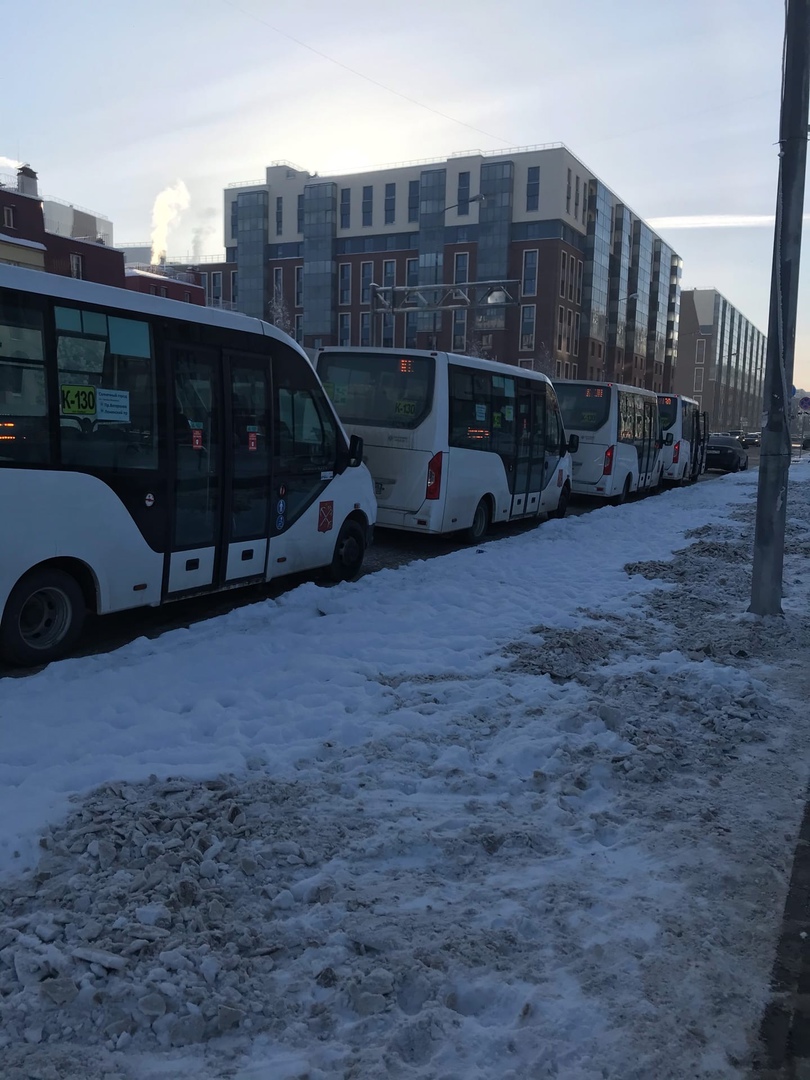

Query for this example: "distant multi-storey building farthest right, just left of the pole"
[673,288,768,431]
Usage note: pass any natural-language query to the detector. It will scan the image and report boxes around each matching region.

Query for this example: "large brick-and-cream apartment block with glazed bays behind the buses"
[225,145,681,390]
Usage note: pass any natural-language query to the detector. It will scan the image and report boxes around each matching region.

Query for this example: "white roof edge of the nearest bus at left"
[0,264,307,356]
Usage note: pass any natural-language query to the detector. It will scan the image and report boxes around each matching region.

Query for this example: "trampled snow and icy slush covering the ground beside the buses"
[0,464,810,1080]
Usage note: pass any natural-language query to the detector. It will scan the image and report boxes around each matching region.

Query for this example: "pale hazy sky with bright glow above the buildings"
[0,0,810,387]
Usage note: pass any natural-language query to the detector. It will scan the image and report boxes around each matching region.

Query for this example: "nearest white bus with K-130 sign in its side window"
[0,266,376,664]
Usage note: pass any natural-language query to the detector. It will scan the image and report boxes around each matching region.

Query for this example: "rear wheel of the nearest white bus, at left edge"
[0,569,87,667]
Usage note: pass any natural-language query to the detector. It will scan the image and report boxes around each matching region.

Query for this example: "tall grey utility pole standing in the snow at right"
[748,0,810,615]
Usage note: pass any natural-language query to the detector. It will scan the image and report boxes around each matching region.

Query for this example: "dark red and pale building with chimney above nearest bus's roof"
[0,165,124,287]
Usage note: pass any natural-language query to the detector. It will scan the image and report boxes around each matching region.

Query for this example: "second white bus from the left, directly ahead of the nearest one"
[315,348,571,543]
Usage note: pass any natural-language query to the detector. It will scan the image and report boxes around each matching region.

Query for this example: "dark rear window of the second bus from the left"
[318,352,435,428]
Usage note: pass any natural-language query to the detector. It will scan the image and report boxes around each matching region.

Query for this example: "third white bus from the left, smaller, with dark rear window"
[554,379,663,505]
